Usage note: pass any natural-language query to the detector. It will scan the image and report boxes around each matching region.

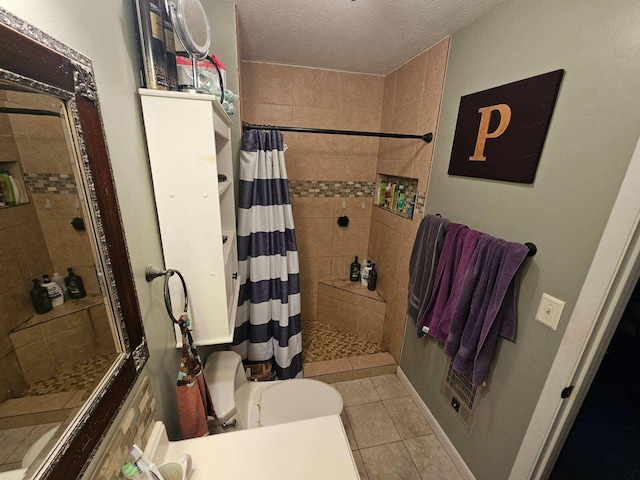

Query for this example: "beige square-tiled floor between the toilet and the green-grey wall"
[333,374,462,480]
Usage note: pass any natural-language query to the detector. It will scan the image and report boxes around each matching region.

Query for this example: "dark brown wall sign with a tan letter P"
[449,70,564,183]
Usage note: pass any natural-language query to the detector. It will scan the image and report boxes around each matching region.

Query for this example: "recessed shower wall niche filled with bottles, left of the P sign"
[373,173,418,219]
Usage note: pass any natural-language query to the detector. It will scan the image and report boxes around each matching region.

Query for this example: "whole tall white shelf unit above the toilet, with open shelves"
[139,89,240,347]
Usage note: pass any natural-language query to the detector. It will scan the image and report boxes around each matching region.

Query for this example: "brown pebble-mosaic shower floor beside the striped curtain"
[302,322,384,363]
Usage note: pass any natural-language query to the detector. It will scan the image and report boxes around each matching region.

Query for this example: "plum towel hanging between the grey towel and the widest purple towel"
[418,227,482,342]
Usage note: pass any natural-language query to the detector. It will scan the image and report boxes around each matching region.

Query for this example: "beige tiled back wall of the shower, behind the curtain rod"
[241,62,384,320]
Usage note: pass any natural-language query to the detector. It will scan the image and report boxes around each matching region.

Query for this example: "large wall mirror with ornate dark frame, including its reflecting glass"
[0,8,148,479]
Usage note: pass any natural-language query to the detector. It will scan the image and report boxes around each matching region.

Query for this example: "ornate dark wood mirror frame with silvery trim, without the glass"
[0,8,149,480]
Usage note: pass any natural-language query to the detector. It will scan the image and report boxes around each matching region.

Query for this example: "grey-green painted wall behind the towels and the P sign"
[401,0,640,480]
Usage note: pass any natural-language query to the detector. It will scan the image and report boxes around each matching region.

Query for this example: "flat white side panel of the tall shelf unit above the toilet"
[142,90,233,345]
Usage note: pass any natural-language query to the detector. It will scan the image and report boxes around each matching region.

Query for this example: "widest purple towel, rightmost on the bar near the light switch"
[445,234,528,387]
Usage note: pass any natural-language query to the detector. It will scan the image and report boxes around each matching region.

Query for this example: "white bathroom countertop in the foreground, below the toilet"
[145,415,360,480]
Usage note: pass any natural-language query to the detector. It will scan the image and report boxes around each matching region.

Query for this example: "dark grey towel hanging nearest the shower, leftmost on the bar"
[407,215,449,323]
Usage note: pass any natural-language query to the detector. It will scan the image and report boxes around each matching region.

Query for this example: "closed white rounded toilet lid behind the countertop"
[260,378,342,426]
